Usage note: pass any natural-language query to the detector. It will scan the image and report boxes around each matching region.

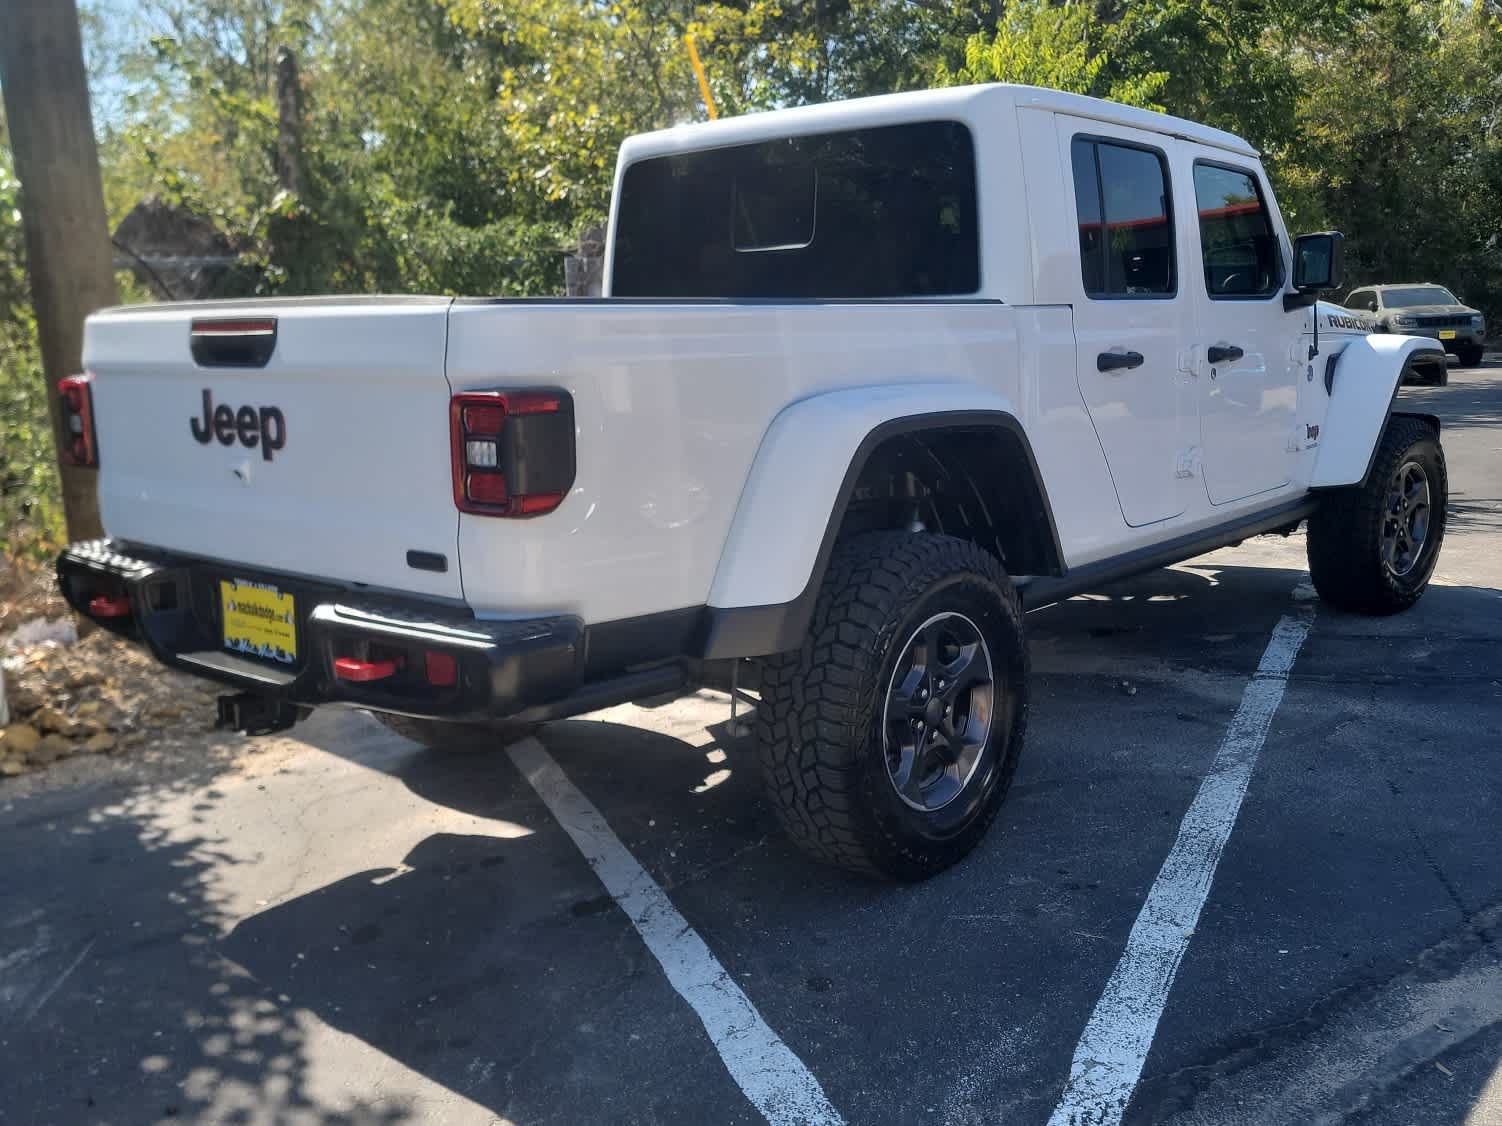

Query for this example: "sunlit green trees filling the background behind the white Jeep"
[0,0,1502,552]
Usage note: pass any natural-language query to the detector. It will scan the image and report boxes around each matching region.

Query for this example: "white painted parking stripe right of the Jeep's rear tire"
[1048,592,1314,1126]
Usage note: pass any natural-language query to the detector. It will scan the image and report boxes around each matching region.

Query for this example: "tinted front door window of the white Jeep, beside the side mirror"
[1194,161,1283,300]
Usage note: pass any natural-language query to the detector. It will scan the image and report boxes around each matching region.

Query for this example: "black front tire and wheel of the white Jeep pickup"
[1308,416,1449,614]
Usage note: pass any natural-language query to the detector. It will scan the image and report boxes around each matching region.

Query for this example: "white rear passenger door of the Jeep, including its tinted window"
[1057,114,1194,527]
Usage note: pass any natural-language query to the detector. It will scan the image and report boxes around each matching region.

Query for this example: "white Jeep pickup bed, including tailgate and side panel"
[86,297,1078,622]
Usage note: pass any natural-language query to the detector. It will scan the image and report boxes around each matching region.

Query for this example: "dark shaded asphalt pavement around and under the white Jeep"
[0,560,1502,1123]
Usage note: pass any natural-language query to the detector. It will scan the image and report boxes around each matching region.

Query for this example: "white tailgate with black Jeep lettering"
[84,297,461,599]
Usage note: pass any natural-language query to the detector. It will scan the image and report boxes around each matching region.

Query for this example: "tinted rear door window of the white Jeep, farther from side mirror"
[1069,137,1178,299]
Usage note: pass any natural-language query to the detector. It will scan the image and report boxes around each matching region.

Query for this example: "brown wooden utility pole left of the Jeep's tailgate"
[0,0,119,540]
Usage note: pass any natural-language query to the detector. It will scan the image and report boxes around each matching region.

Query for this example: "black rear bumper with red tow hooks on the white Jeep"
[57,540,588,719]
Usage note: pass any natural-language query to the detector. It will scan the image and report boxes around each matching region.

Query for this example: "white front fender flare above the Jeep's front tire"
[1310,335,1445,488]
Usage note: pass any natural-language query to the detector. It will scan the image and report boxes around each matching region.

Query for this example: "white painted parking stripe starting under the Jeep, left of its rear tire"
[509,739,844,1126]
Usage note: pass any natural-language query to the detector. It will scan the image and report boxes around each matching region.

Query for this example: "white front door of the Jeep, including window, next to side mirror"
[1179,152,1307,504]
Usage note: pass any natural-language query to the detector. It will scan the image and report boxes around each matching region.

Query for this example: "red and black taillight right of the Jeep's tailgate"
[449,390,574,516]
